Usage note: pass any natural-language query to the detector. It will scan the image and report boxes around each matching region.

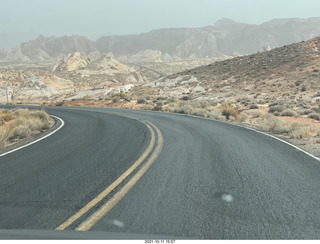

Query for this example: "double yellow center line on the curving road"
[56,110,163,231]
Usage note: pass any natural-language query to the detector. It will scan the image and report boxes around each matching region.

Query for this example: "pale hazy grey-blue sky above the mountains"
[0,0,320,39]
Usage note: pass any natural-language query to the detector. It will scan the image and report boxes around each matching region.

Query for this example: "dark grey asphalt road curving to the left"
[0,108,320,239]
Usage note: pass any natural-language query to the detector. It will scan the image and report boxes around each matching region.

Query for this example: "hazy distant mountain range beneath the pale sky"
[0,17,320,62]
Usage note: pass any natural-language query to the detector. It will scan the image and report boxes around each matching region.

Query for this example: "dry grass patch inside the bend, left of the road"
[0,109,51,148]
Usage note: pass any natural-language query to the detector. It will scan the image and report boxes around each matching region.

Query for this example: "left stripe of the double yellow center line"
[56,122,155,230]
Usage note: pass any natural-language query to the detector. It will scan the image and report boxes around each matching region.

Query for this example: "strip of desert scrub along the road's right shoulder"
[137,96,320,140]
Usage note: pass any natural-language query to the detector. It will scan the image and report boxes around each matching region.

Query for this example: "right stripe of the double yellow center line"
[76,123,163,231]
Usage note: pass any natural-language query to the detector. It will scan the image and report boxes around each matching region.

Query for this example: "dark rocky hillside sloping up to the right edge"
[136,37,320,102]
